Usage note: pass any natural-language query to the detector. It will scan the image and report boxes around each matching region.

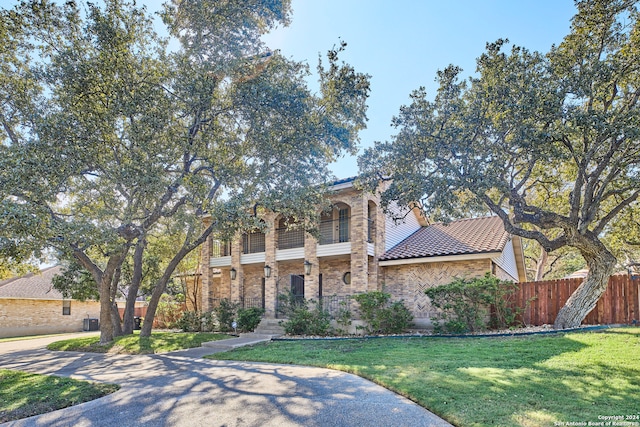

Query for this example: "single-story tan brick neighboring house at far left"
[0,266,100,338]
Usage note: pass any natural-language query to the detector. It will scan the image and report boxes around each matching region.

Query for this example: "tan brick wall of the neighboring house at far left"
[0,298,100,338]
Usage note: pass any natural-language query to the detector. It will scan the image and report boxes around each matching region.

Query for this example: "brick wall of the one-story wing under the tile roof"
[381,260,491,326]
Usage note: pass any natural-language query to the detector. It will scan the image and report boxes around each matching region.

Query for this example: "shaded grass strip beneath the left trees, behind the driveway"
[47,332,230,354]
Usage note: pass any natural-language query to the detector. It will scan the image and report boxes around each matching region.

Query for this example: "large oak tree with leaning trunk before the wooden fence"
[360,0,640,327]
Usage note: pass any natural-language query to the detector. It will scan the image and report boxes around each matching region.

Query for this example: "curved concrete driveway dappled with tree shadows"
[0,333,450,427]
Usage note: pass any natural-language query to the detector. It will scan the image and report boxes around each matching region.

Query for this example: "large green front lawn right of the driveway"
[208,328,640,427]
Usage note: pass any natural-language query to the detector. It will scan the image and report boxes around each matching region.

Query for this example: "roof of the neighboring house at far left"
[0,265,63,300]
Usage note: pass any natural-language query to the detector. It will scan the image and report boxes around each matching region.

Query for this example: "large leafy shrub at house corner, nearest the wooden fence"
[425,273,522,333]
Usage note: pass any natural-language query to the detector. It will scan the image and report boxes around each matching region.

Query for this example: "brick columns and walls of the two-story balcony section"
[201,181,385,317]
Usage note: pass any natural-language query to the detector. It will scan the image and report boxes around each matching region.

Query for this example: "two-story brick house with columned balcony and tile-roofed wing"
[202,178,526,326]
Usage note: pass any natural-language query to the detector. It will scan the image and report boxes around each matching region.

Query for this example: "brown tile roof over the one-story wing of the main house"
[380,216,509,261]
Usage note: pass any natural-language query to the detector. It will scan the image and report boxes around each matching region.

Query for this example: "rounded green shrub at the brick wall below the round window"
[352,291,413,334]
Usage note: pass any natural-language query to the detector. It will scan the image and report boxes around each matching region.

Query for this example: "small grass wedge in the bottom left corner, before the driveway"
[0,369,120,423]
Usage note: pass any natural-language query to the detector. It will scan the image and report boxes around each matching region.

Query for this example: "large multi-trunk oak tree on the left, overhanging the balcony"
[0,0,369,342]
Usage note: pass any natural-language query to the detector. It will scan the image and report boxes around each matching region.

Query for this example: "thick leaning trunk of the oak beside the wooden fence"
[553,247,616,329]
